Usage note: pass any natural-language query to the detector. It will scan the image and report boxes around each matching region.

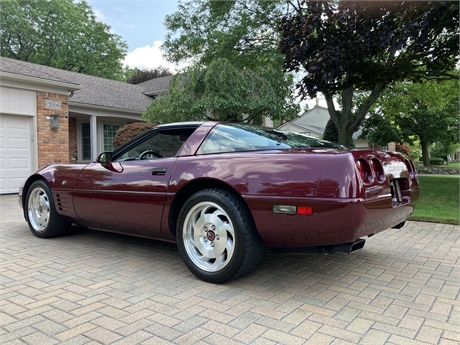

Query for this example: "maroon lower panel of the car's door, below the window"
[73,157,177,238]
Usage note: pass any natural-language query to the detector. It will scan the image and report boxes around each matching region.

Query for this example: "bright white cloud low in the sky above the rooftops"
[123,41,183,73]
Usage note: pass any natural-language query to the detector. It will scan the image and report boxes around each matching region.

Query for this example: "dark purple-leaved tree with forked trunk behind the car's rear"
[280,0,459,146]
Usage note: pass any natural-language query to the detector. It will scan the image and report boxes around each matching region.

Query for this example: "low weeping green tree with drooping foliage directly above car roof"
[143,58,299,123]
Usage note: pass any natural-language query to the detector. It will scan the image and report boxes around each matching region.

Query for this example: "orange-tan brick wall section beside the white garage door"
[37,91,70,168]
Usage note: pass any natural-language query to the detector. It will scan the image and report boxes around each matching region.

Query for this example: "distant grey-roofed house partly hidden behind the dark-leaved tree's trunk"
[278,105,377,149]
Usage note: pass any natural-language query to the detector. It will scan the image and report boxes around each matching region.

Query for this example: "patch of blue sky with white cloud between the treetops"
[87,0,178,72]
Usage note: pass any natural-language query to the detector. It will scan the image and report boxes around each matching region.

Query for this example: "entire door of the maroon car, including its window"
[72,127,196,239]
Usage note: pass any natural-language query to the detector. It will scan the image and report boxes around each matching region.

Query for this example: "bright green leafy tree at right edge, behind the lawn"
[362,80,459,166]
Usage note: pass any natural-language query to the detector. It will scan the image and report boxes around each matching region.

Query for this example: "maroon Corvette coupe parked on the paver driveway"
[19,122,420,283]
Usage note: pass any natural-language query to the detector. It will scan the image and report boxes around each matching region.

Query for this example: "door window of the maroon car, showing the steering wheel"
[115,129,194,162]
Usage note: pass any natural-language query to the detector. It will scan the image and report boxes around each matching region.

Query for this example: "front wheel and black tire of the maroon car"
[24,180,72,238]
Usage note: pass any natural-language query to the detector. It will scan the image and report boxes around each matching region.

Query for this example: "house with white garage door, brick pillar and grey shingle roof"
[0,57,172,194]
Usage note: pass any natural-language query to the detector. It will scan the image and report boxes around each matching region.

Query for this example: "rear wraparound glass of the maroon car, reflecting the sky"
[198,124,343,154]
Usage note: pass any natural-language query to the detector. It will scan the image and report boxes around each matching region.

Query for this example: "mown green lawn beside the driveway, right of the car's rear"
[409,175,460,225]
